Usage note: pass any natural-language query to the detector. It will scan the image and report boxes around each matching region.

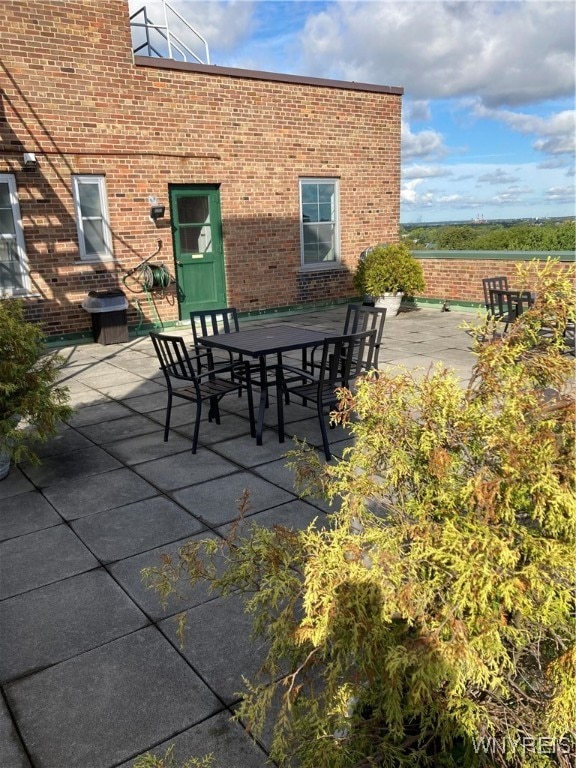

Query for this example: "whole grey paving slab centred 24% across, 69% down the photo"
[72,496,204,563]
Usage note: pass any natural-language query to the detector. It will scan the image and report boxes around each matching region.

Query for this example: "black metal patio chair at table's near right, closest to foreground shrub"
[276,328,377,461]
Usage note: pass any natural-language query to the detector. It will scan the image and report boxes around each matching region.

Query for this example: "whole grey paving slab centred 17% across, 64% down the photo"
[44,467,158,520]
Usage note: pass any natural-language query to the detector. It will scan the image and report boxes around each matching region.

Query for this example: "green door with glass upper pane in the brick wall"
[170,186,226,320]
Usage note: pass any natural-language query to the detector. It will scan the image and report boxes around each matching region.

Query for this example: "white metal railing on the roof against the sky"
[130,0,210,64]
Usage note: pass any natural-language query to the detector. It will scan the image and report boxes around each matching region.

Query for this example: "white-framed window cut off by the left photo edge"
[0,173,30,298]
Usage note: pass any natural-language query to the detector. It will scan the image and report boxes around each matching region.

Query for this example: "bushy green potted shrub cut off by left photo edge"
[0,299,72,479]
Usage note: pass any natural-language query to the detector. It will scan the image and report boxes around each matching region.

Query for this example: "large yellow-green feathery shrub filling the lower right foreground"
[142,264,576,768]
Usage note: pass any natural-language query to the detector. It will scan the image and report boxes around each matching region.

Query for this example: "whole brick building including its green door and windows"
[0,0,402,339]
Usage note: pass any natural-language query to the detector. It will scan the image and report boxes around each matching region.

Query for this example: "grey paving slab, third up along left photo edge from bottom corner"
[0,525,98,599]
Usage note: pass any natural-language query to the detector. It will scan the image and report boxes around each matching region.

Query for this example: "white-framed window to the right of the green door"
[300,178,340,267]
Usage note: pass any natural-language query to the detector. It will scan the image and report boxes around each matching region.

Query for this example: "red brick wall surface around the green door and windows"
[0,0,401,335]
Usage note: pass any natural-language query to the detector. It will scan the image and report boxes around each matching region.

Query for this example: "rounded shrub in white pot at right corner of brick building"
[353,243,425,316]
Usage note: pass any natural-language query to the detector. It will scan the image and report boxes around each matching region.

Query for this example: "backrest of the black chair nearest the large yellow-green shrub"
[318,328,377,387]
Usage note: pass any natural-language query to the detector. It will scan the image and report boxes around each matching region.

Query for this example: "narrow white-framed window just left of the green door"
[72,176,113,261]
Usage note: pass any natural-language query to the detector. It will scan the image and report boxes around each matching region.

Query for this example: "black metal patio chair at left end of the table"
[150,331,256,453]
